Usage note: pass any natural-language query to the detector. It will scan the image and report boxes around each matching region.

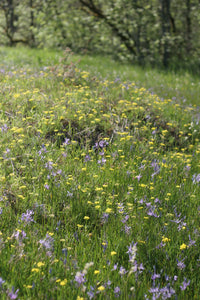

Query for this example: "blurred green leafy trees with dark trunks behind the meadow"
[0,0,200,69]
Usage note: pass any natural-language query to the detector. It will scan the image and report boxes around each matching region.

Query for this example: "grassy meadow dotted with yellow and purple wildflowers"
[0,48,200,300]
